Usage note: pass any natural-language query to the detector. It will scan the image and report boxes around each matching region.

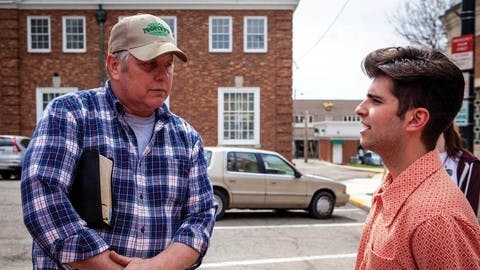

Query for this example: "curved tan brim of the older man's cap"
[128,42,188,62]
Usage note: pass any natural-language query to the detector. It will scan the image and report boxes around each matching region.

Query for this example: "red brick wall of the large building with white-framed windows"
[0,10,292,159]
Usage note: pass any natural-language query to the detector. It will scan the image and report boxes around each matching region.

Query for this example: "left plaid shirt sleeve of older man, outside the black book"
[21,96,108,263]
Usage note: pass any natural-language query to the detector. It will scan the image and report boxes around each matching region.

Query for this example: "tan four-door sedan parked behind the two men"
[205,147,349,220]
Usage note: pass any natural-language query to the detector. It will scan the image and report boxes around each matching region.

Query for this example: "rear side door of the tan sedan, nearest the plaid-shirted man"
[225,151,265,208]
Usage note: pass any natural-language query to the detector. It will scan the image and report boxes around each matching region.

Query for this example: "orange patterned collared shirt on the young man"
[355,150,480,270]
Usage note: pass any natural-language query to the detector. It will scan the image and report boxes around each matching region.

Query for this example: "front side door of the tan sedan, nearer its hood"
[261,154,307,208]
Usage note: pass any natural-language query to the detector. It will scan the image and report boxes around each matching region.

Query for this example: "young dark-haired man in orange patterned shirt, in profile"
[355,48,480,270]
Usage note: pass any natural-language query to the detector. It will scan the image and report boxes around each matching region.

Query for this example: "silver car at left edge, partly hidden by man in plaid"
[0,135,30,179]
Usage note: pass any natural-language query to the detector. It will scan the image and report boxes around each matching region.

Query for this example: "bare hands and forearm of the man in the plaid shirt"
[110,243,200,270]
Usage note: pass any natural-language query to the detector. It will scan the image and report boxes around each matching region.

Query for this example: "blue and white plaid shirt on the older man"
[21,82,215,269]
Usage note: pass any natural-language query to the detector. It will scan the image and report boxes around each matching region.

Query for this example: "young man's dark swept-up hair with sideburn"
[363,47,465,150]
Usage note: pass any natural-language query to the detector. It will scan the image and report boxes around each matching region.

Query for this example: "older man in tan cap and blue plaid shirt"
[21,14,215,269]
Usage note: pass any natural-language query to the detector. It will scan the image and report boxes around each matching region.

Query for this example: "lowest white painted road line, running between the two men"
[200,253,357,269]
